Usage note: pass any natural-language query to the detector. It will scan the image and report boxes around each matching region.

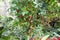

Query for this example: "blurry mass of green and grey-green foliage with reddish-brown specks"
[0,0,60,40]
